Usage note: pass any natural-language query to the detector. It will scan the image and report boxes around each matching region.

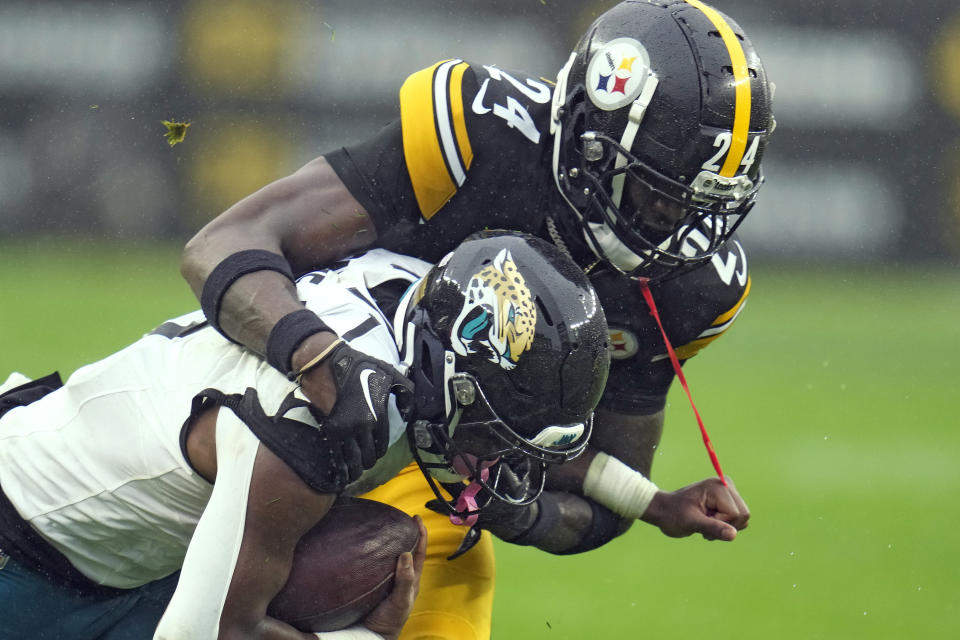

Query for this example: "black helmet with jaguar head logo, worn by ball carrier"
[395,232,610,523]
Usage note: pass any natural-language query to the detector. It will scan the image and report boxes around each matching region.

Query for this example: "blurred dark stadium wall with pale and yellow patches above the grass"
[0,0,960,263]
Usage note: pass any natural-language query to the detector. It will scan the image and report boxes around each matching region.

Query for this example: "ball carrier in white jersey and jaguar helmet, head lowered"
[0,233,610,640]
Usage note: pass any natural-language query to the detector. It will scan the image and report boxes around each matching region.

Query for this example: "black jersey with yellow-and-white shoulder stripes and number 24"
[326,60,750,414]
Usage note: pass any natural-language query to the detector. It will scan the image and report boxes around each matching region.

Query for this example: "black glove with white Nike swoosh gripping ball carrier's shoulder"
[322,342,413,481]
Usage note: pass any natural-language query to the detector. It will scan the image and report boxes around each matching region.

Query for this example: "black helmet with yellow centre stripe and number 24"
[551,0,774,279]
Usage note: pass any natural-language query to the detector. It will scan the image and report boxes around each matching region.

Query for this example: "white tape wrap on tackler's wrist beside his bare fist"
[583,452,659,518]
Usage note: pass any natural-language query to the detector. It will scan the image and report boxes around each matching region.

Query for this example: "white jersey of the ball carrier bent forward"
[0,250,430,588]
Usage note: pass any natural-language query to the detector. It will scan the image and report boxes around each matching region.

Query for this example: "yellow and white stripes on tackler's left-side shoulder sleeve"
[400,60,473,220]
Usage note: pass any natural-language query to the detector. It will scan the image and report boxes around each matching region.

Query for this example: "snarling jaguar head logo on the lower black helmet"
[450,249,537,371]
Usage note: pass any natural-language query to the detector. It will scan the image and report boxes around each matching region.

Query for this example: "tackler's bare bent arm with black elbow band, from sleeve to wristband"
[180,157,376,354]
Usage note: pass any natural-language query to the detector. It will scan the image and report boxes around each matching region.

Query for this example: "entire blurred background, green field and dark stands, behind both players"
[0,0,960,640]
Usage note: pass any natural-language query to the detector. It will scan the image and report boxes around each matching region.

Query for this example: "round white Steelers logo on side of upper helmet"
[586,38,650,111]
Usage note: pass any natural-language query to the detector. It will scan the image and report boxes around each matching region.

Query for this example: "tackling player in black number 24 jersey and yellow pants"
[182,0,774,638]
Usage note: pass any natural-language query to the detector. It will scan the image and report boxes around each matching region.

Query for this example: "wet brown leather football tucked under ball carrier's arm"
[267,498,420,632]
